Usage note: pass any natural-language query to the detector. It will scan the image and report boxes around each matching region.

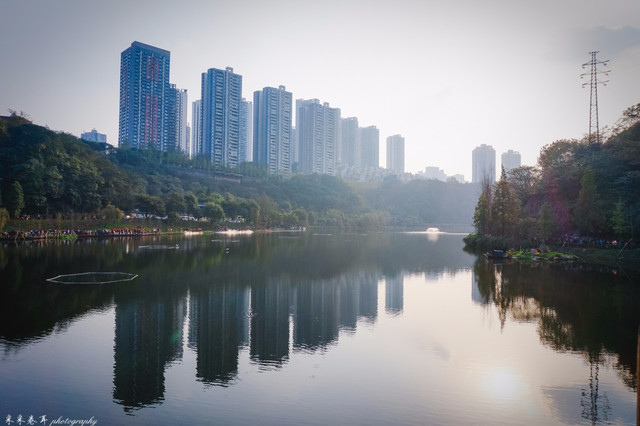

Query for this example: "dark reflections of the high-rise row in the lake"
[113,272,384,410]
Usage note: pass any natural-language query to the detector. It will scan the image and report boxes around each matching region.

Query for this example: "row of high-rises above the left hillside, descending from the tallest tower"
[118,41,404,174]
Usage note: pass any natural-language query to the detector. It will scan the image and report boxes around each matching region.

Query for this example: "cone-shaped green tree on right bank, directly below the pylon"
[573,166,603,235]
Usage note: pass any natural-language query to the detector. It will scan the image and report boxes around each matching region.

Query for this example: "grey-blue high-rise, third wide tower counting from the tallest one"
[253,86,292,173]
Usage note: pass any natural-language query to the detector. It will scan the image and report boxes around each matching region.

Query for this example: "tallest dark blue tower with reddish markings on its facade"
[118,41,175,151]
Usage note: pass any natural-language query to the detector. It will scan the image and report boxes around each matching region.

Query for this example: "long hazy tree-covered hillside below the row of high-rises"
[0,113,477,230]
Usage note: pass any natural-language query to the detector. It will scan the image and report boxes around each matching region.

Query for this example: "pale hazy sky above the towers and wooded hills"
[0,0,640,180]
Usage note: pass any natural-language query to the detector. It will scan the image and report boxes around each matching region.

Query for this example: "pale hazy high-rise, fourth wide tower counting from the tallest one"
[296,99,340,175]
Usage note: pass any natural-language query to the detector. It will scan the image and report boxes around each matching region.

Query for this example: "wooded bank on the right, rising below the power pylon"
[470,104,640,245]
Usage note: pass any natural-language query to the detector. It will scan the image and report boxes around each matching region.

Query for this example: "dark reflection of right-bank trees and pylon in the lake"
[473,259,640,424]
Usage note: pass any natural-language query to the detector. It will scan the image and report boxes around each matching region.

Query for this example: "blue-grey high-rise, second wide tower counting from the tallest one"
[201,67,242,167]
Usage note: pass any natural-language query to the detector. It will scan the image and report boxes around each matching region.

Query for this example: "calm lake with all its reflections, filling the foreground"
[0,232,640,425]
